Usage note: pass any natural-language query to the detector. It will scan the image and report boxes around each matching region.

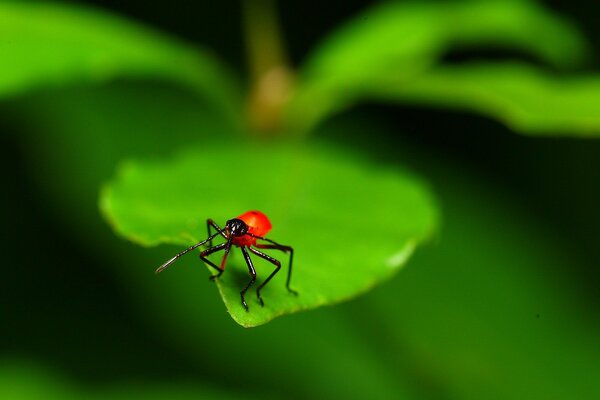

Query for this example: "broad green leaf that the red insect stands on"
[101,142,437,327]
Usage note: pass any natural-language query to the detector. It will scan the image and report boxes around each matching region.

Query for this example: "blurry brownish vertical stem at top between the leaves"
[242,0,293,134]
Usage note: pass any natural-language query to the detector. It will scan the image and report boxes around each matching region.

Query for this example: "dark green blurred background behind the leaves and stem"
[0,0,600,399]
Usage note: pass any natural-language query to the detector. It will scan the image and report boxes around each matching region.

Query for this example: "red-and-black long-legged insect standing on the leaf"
[156,211,298,311]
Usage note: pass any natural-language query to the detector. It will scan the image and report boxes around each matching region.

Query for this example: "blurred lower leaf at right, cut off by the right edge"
[373,63,600,136]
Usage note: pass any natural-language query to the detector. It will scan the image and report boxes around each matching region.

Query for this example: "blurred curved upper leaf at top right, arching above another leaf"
[288,1,588,133]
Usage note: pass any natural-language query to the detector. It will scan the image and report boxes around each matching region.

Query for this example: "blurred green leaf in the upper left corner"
[0,2,239,119]
